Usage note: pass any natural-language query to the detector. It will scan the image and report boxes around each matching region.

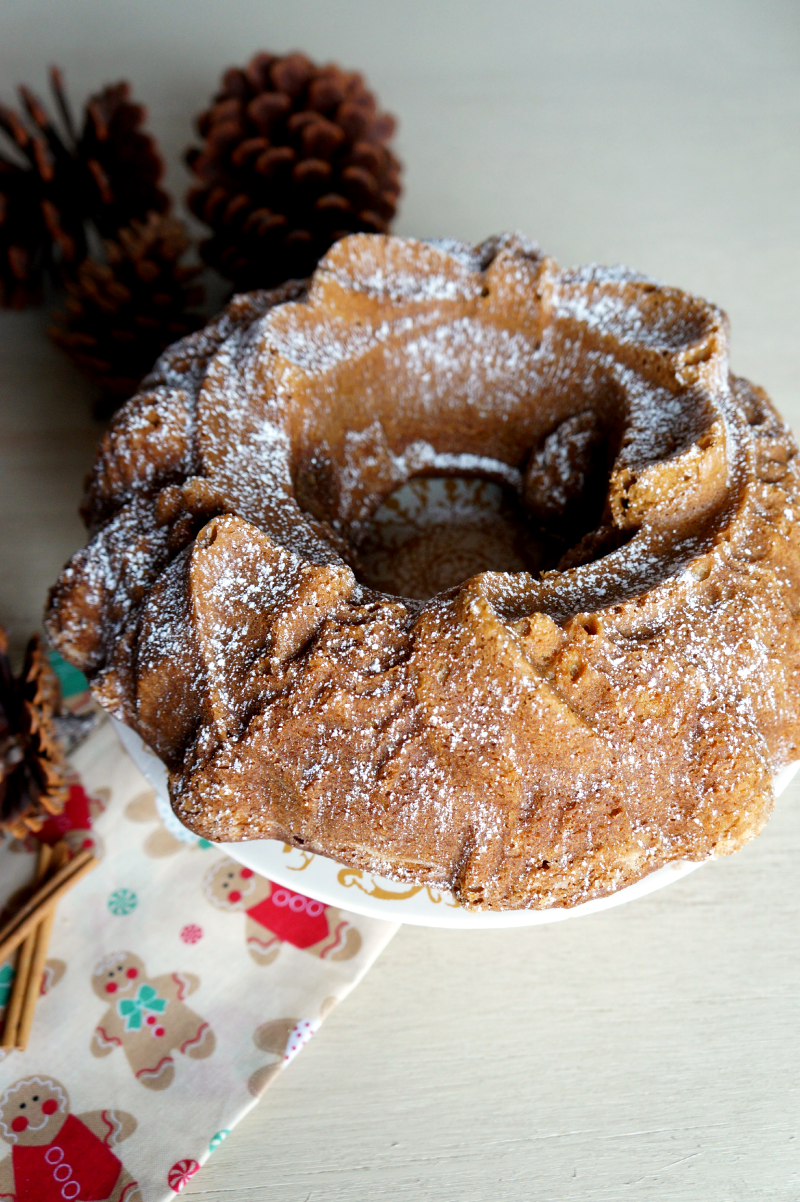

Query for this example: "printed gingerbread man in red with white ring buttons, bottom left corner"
[0,1077,142,1202]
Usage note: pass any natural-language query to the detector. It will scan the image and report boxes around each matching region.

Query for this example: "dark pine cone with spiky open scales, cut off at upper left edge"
[0,69,169,308]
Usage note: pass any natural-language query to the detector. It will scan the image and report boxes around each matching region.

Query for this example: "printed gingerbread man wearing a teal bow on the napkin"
[90,952,216,1089]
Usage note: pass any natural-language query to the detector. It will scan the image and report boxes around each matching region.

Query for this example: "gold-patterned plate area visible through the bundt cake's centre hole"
[358,476,549,601]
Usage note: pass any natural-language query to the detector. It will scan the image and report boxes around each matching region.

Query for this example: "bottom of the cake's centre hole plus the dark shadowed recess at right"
[353,411,633,601]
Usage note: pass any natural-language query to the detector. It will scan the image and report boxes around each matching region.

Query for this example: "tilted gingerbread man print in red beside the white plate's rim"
[203,856,362,964]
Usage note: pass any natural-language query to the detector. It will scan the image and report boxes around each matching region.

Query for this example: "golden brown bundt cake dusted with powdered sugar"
[48,236,800,908]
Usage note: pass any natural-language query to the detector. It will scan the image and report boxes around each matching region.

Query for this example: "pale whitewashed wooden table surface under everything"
[0,0,800,1202]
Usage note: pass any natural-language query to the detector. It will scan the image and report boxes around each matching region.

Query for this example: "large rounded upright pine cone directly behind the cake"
[186,54,400,290]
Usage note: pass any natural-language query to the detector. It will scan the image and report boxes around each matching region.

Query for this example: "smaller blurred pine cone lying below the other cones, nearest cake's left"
[50,213,203,417]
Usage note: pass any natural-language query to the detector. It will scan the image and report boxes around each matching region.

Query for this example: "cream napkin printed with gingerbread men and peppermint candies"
[0,721,396,1202]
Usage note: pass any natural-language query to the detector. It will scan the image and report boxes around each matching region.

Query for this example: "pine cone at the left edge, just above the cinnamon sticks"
[0,627,68,839]
